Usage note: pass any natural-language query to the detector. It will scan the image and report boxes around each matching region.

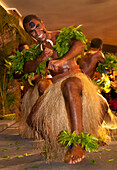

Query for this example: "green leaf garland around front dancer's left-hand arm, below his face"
[5,44,49,85]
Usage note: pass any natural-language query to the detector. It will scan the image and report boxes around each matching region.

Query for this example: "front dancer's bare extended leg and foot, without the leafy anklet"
[62,77,85,164]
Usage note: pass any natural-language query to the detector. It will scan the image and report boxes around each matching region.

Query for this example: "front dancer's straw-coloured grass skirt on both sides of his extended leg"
[32,73,109,143]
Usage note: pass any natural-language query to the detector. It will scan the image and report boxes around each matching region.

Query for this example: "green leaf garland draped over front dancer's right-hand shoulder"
[53,25,87,58]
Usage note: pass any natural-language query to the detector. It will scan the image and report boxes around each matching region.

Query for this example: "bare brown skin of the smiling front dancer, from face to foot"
[24,19,105,164]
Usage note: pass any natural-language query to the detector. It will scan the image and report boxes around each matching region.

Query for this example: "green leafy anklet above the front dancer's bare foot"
[58,131,99,152]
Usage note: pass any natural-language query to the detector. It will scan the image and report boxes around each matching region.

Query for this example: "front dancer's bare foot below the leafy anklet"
[64,145,85,164]
